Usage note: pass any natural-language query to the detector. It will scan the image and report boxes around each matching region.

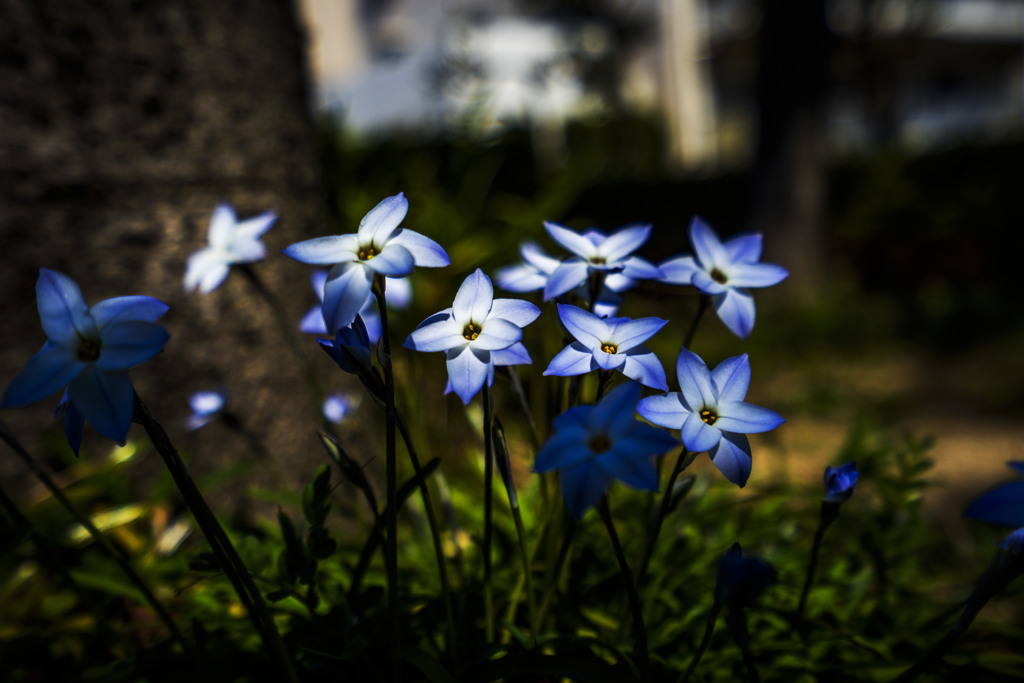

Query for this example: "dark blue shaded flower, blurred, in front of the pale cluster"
[534,382,678,518]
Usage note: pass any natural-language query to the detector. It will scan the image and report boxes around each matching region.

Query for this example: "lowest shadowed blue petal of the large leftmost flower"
[68,366,135,445]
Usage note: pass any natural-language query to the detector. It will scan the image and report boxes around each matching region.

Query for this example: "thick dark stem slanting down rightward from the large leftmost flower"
[132,393,298,682]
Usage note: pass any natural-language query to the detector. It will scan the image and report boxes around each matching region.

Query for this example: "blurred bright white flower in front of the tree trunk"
[185,204,278,294]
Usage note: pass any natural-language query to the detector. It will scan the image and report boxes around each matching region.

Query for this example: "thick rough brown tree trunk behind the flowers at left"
[0,0,352,507]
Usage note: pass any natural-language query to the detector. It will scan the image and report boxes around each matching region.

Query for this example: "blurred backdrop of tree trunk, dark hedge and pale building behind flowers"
[0,0,1024,532]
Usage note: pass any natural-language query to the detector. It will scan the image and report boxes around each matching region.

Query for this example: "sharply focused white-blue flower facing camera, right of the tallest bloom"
[404,268,541,405]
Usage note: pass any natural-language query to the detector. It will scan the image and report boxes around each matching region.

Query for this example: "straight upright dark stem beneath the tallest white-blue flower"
[373,275,400,677]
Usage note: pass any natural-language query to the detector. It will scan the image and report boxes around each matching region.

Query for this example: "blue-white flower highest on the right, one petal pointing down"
[658,216,790,339]
